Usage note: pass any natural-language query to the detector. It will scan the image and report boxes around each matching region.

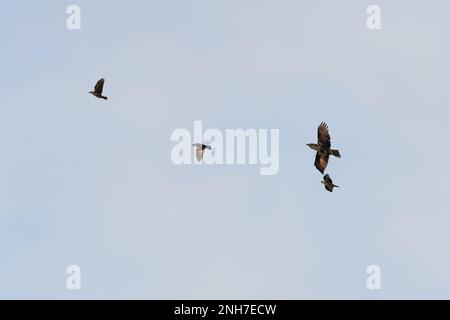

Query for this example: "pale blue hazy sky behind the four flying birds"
[0,0,450,299]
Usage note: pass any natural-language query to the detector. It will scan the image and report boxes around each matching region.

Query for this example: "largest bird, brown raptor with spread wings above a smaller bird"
[306,122,341,174]
